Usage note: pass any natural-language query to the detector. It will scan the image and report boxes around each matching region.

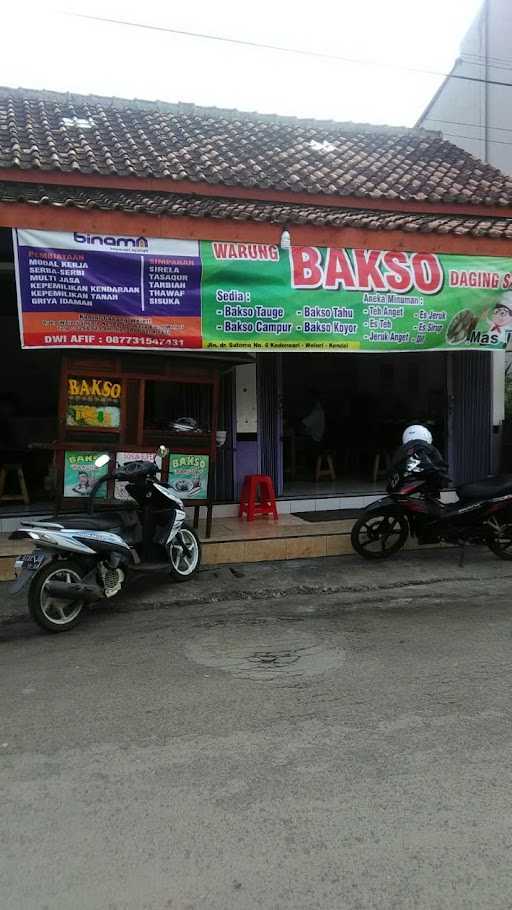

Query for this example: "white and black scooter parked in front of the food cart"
[11,446,201,632]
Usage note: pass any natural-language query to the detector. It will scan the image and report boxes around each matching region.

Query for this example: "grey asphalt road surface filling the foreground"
[0,564,512,910]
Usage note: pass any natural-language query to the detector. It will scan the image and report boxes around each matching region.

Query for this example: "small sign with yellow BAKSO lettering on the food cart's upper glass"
[66,376,122,430]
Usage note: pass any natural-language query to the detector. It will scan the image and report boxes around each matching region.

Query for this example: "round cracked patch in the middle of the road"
[185,621,345,682]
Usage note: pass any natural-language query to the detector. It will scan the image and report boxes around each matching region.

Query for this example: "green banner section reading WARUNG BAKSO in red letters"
[200,241,512,351]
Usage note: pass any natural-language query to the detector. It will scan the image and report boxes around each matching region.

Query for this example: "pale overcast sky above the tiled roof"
[0,0,481,126]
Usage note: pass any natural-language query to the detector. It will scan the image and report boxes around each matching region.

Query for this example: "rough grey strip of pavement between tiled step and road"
[0,548,512,626]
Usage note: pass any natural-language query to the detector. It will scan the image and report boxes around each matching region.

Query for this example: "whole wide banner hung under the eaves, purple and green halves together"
[13,230,512,351]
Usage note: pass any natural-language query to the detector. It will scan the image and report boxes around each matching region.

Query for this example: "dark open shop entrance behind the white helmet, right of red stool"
[282,352,448,496]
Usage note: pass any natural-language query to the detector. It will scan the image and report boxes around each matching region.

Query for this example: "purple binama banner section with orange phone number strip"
[14,230,202,349]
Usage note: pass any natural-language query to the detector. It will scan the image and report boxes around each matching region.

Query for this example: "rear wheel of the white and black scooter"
[28,559,84,632]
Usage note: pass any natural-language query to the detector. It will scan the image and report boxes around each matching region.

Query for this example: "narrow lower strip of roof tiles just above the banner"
[0,181,512,239]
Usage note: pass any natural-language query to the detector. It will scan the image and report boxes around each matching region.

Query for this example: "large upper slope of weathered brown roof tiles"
[0,88,512,206]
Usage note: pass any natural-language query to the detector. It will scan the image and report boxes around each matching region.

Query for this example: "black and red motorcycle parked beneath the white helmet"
[351,446,512,559]
